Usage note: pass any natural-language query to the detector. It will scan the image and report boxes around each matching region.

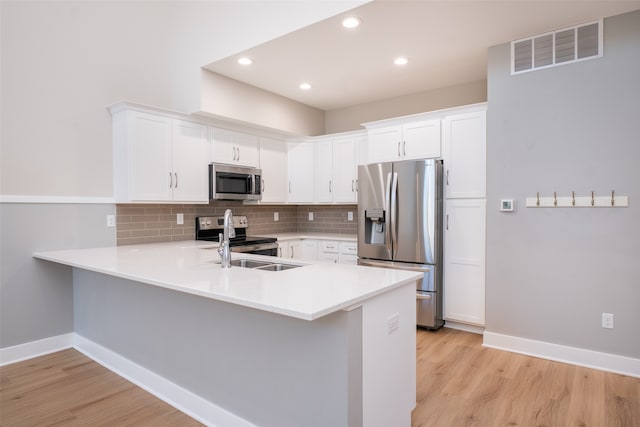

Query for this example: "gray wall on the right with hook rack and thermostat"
[486,11,640,358]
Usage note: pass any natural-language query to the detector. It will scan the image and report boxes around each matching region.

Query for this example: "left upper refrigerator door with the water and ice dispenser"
[358,163,393,260]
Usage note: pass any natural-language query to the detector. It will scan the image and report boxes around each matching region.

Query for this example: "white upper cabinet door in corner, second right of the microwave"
[287,142,314,203]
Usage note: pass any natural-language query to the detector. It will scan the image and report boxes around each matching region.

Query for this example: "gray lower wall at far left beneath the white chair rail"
[0,203,115,348]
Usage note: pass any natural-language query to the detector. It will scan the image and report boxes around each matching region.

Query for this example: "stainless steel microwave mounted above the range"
[209,163,262,200]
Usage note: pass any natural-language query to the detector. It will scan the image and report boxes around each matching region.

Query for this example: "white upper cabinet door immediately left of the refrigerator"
[333,138,358,203]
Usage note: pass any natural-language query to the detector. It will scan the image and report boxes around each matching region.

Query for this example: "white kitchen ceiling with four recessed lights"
[205,0,640,110]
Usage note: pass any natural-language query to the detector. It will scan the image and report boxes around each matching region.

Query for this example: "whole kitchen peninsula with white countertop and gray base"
[34,241,420,426]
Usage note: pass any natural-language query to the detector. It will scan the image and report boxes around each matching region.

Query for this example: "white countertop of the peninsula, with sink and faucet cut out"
[33,241,421,320]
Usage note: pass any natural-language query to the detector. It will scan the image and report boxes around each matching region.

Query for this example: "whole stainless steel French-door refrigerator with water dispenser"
[358,159,444,329]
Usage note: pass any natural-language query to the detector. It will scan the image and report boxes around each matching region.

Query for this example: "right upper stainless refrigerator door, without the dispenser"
[390,160,442,264]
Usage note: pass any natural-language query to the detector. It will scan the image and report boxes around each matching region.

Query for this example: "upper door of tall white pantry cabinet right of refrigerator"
[442,111,487,198]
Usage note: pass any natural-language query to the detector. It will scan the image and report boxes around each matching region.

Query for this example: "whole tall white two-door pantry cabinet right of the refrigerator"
[442,105,487,326]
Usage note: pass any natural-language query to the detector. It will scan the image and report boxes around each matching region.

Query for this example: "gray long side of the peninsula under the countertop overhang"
[73,269,363,427]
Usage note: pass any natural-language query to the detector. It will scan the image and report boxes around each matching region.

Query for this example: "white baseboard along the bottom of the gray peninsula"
[74,334,255,427]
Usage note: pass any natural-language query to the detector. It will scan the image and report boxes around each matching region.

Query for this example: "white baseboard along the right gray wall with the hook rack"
[482,332,640,378]
